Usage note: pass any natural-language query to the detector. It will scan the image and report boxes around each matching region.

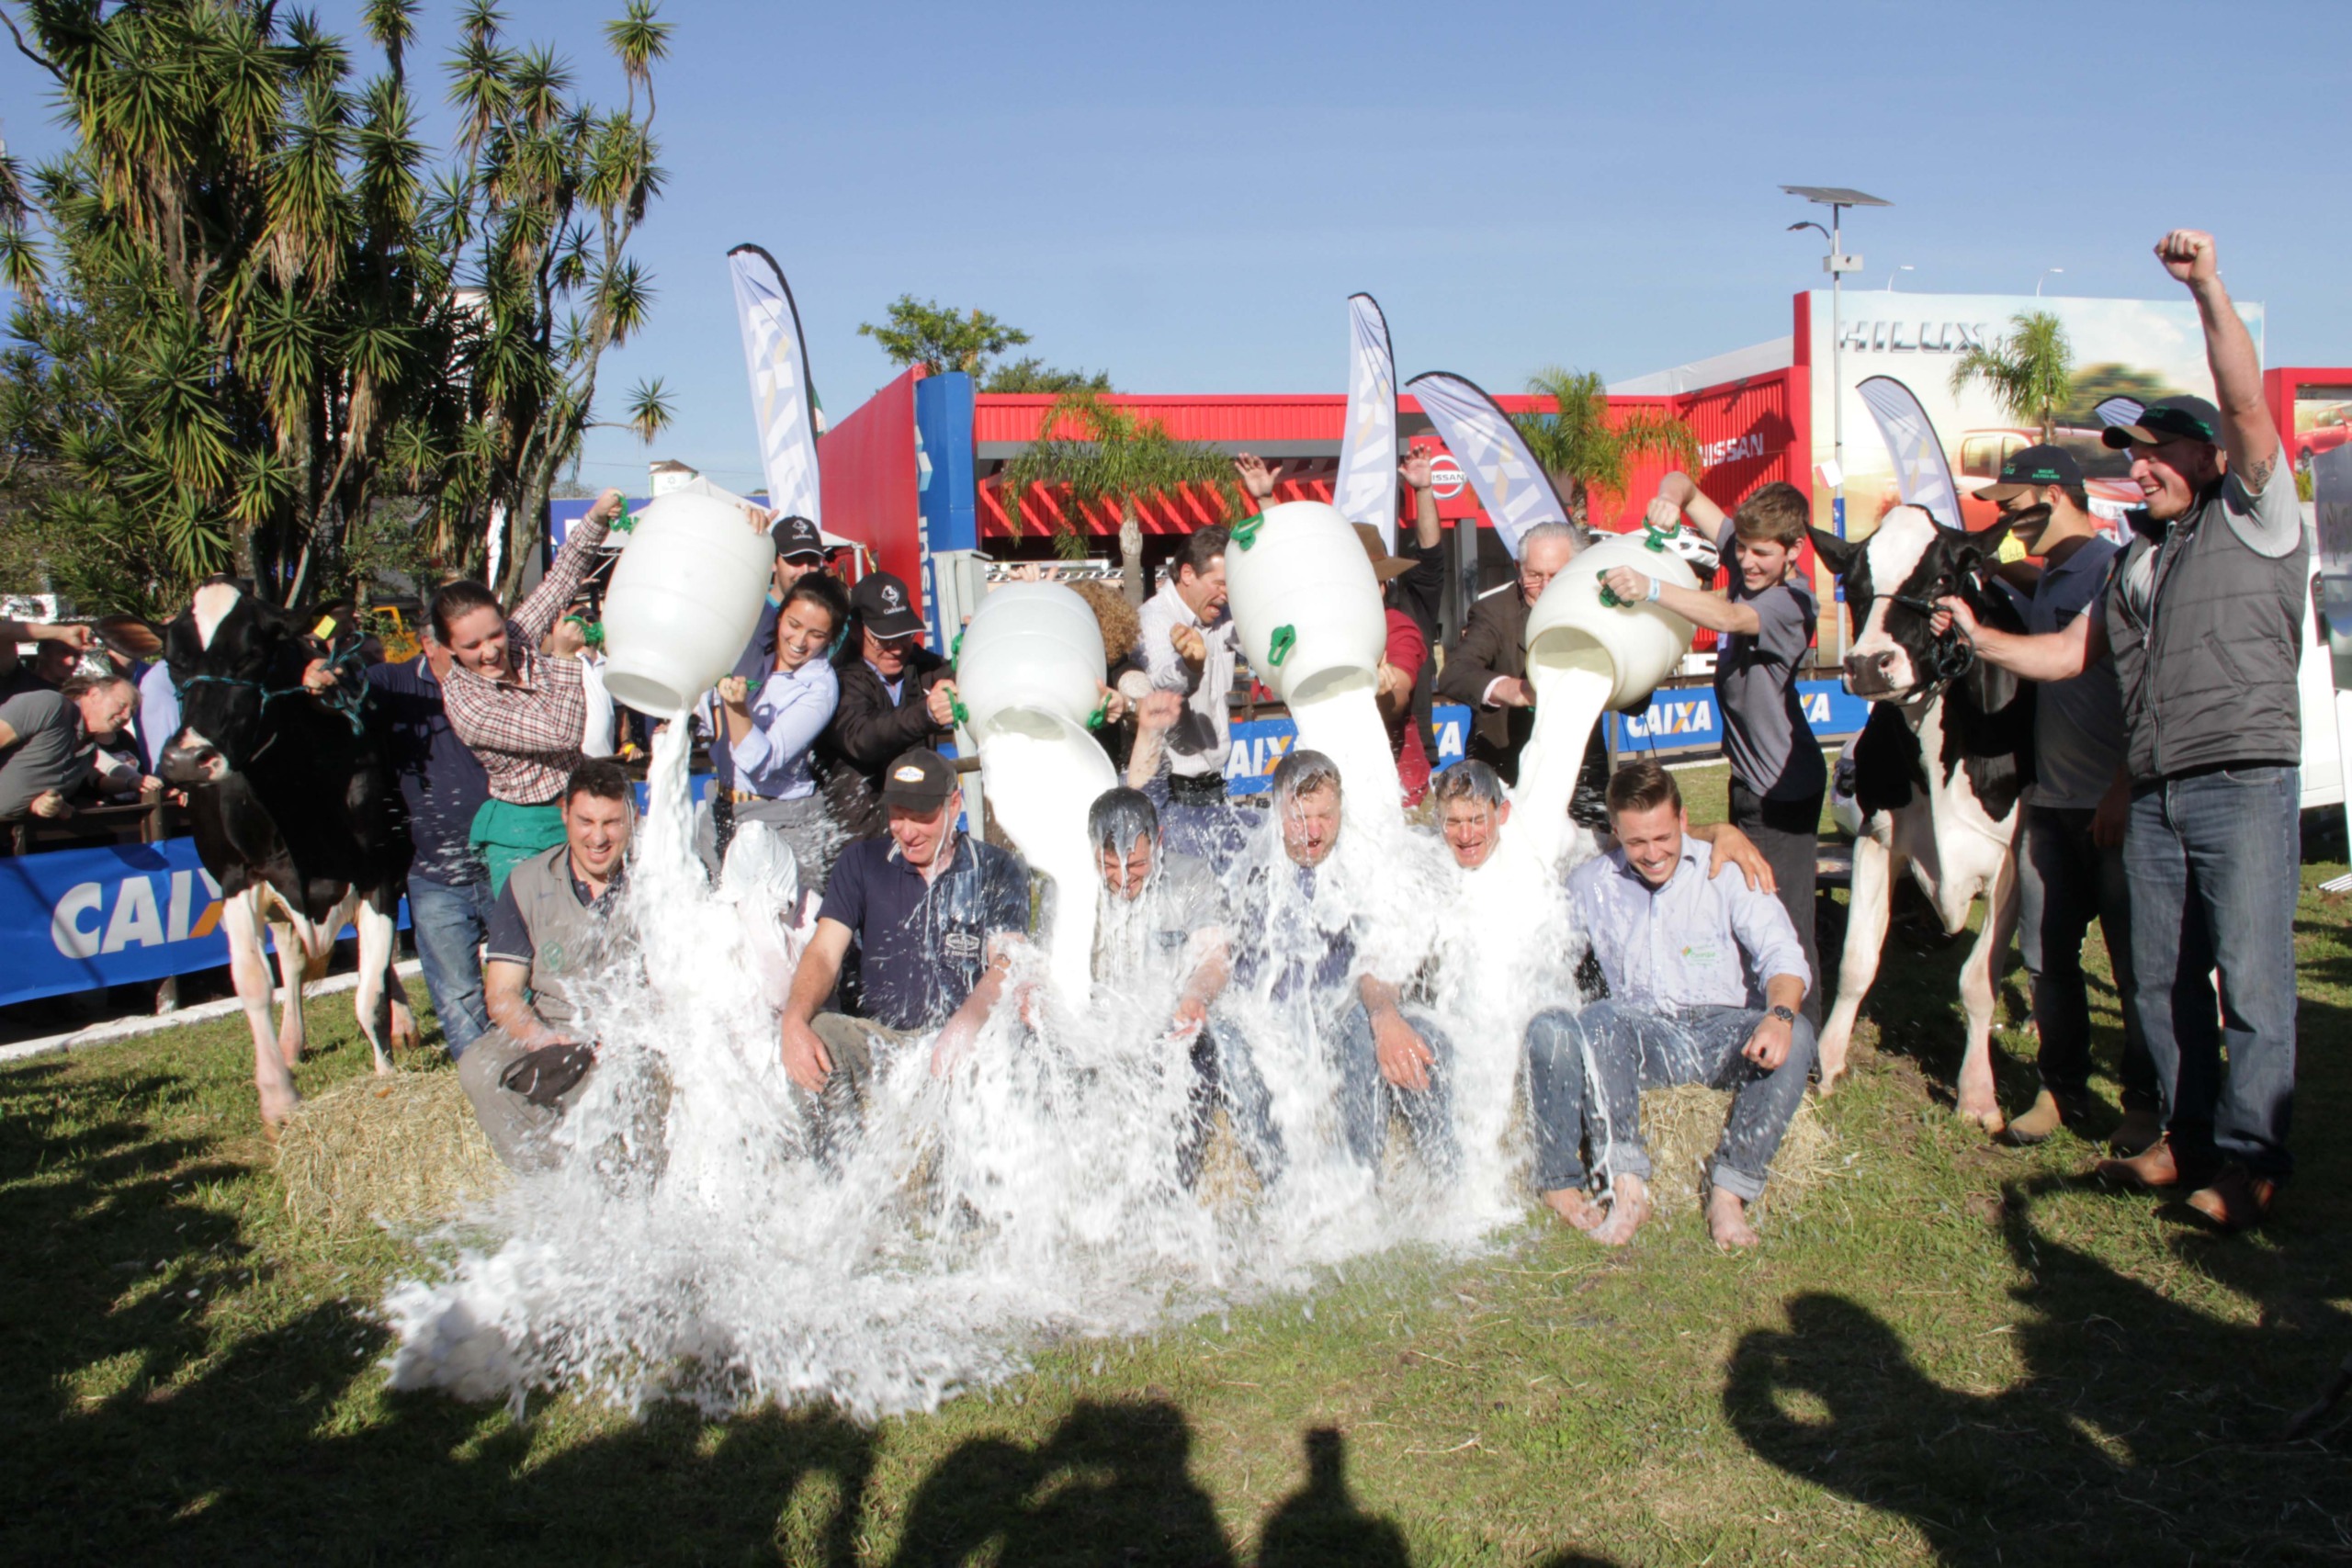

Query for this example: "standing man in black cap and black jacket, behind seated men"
[811,571,955,840]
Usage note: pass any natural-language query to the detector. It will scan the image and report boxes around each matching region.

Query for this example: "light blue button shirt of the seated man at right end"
[1569,837,1814,1009]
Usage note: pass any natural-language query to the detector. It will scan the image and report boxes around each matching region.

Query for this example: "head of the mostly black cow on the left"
[158,583,311,785]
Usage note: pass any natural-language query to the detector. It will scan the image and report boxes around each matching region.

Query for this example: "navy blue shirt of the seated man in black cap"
[816,832,1028,1030]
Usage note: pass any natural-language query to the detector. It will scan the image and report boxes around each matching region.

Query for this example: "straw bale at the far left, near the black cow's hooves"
[277,1069,505,1229]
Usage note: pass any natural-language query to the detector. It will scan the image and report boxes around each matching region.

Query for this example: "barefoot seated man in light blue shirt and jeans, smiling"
[1526,761,1814,1246]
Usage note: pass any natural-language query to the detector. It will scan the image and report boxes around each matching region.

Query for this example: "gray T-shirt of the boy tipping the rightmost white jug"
[1714,520,1830,799]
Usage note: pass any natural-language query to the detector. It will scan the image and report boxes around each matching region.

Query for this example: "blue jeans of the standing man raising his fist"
[2124,766,2302,1178]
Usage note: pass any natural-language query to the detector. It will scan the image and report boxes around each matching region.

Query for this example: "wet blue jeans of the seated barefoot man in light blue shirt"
[1526,1001,1814,1201]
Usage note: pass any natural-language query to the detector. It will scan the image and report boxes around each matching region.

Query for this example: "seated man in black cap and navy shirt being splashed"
[783,742,1030,1161]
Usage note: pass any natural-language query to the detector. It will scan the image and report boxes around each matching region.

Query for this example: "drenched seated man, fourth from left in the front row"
[1216,750,1461,1176]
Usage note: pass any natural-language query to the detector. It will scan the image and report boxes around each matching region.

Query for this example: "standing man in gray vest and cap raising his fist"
[1943,228,2310,1229]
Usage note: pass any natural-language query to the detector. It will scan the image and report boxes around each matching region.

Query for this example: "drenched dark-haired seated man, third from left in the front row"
[1087,787,1282,1187]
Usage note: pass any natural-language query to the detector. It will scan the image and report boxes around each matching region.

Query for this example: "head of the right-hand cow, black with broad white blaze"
[1814,505,2008,701]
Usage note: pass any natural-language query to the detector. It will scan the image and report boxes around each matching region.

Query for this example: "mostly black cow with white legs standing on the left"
[160,583,416,1126]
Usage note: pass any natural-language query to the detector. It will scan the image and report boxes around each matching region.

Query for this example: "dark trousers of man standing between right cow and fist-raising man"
[2018,807,2162,1110]
